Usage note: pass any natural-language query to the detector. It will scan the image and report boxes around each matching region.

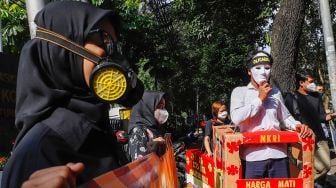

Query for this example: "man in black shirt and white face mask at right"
[285,71,336,186]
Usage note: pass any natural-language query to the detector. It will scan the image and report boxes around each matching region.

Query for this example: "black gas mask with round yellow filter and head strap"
[36,27,144,107]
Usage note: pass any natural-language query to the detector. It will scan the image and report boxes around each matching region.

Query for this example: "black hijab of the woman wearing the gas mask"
[15,1,118,147]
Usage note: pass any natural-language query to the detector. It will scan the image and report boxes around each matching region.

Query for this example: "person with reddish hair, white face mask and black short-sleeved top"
[204,101,231,157]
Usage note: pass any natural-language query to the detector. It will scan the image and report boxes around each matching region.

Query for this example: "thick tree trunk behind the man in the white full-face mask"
[271,0,305,92]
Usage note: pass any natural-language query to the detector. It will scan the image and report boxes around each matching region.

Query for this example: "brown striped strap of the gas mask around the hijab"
[35,26,102,64]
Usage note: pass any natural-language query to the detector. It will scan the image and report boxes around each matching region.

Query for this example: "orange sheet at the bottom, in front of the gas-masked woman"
[79,136,178,188]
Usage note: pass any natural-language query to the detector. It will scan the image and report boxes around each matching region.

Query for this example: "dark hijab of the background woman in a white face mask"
[128,91,165,137]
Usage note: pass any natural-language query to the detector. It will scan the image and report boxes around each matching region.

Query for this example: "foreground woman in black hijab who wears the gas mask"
[1,1,130,188]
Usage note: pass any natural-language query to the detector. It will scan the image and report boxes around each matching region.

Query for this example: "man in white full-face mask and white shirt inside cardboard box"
[230,51,312,179]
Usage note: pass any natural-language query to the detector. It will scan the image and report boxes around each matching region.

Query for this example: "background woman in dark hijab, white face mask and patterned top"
[128,91,169,160]
